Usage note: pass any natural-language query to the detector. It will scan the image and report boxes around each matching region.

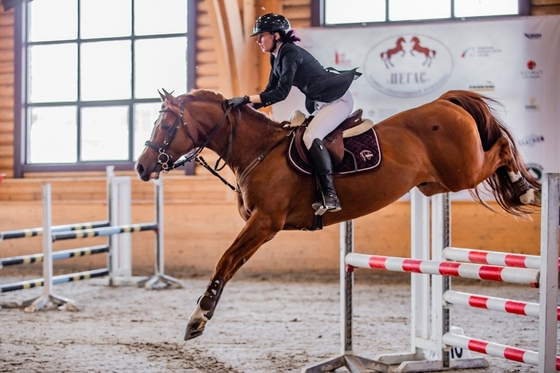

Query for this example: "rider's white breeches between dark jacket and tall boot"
[303,91,354,149]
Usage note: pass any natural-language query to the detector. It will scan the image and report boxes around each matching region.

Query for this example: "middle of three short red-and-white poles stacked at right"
[443,290,560,321]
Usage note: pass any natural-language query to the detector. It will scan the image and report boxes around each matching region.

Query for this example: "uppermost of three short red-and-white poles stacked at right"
[443,247,560,269]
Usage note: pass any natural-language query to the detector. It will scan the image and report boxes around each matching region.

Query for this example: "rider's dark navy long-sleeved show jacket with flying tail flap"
[254,43,361,113]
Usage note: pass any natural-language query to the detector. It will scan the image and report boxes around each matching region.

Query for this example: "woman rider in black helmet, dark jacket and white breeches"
[227,13,361,212]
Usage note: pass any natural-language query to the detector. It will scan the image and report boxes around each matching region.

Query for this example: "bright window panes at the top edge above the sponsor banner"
[322,0,530,26]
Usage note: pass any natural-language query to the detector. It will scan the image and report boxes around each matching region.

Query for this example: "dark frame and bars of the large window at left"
[13,0,197,178]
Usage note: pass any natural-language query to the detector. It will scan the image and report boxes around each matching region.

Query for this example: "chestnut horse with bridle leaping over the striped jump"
[135,90,541,340]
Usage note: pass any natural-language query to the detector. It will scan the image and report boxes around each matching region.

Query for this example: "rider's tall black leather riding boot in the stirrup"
[309,139,340,212]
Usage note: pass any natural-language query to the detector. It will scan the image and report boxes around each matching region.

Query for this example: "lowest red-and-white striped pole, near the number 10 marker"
[443,333,560,370]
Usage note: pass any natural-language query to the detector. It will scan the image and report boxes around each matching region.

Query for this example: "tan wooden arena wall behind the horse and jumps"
[0,0,560,276]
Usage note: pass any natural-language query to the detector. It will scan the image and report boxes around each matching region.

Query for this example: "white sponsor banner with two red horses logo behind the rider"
[273,15,560,176]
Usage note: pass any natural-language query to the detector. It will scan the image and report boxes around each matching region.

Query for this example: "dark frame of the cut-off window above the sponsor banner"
[311,0,531,27]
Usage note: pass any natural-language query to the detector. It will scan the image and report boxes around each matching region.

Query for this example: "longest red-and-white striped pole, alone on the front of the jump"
[346,253,539,284]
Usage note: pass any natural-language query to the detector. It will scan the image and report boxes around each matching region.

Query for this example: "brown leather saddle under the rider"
[284,109,373,166]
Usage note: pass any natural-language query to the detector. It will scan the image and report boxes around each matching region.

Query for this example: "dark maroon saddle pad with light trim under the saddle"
[287,127,381,176]
